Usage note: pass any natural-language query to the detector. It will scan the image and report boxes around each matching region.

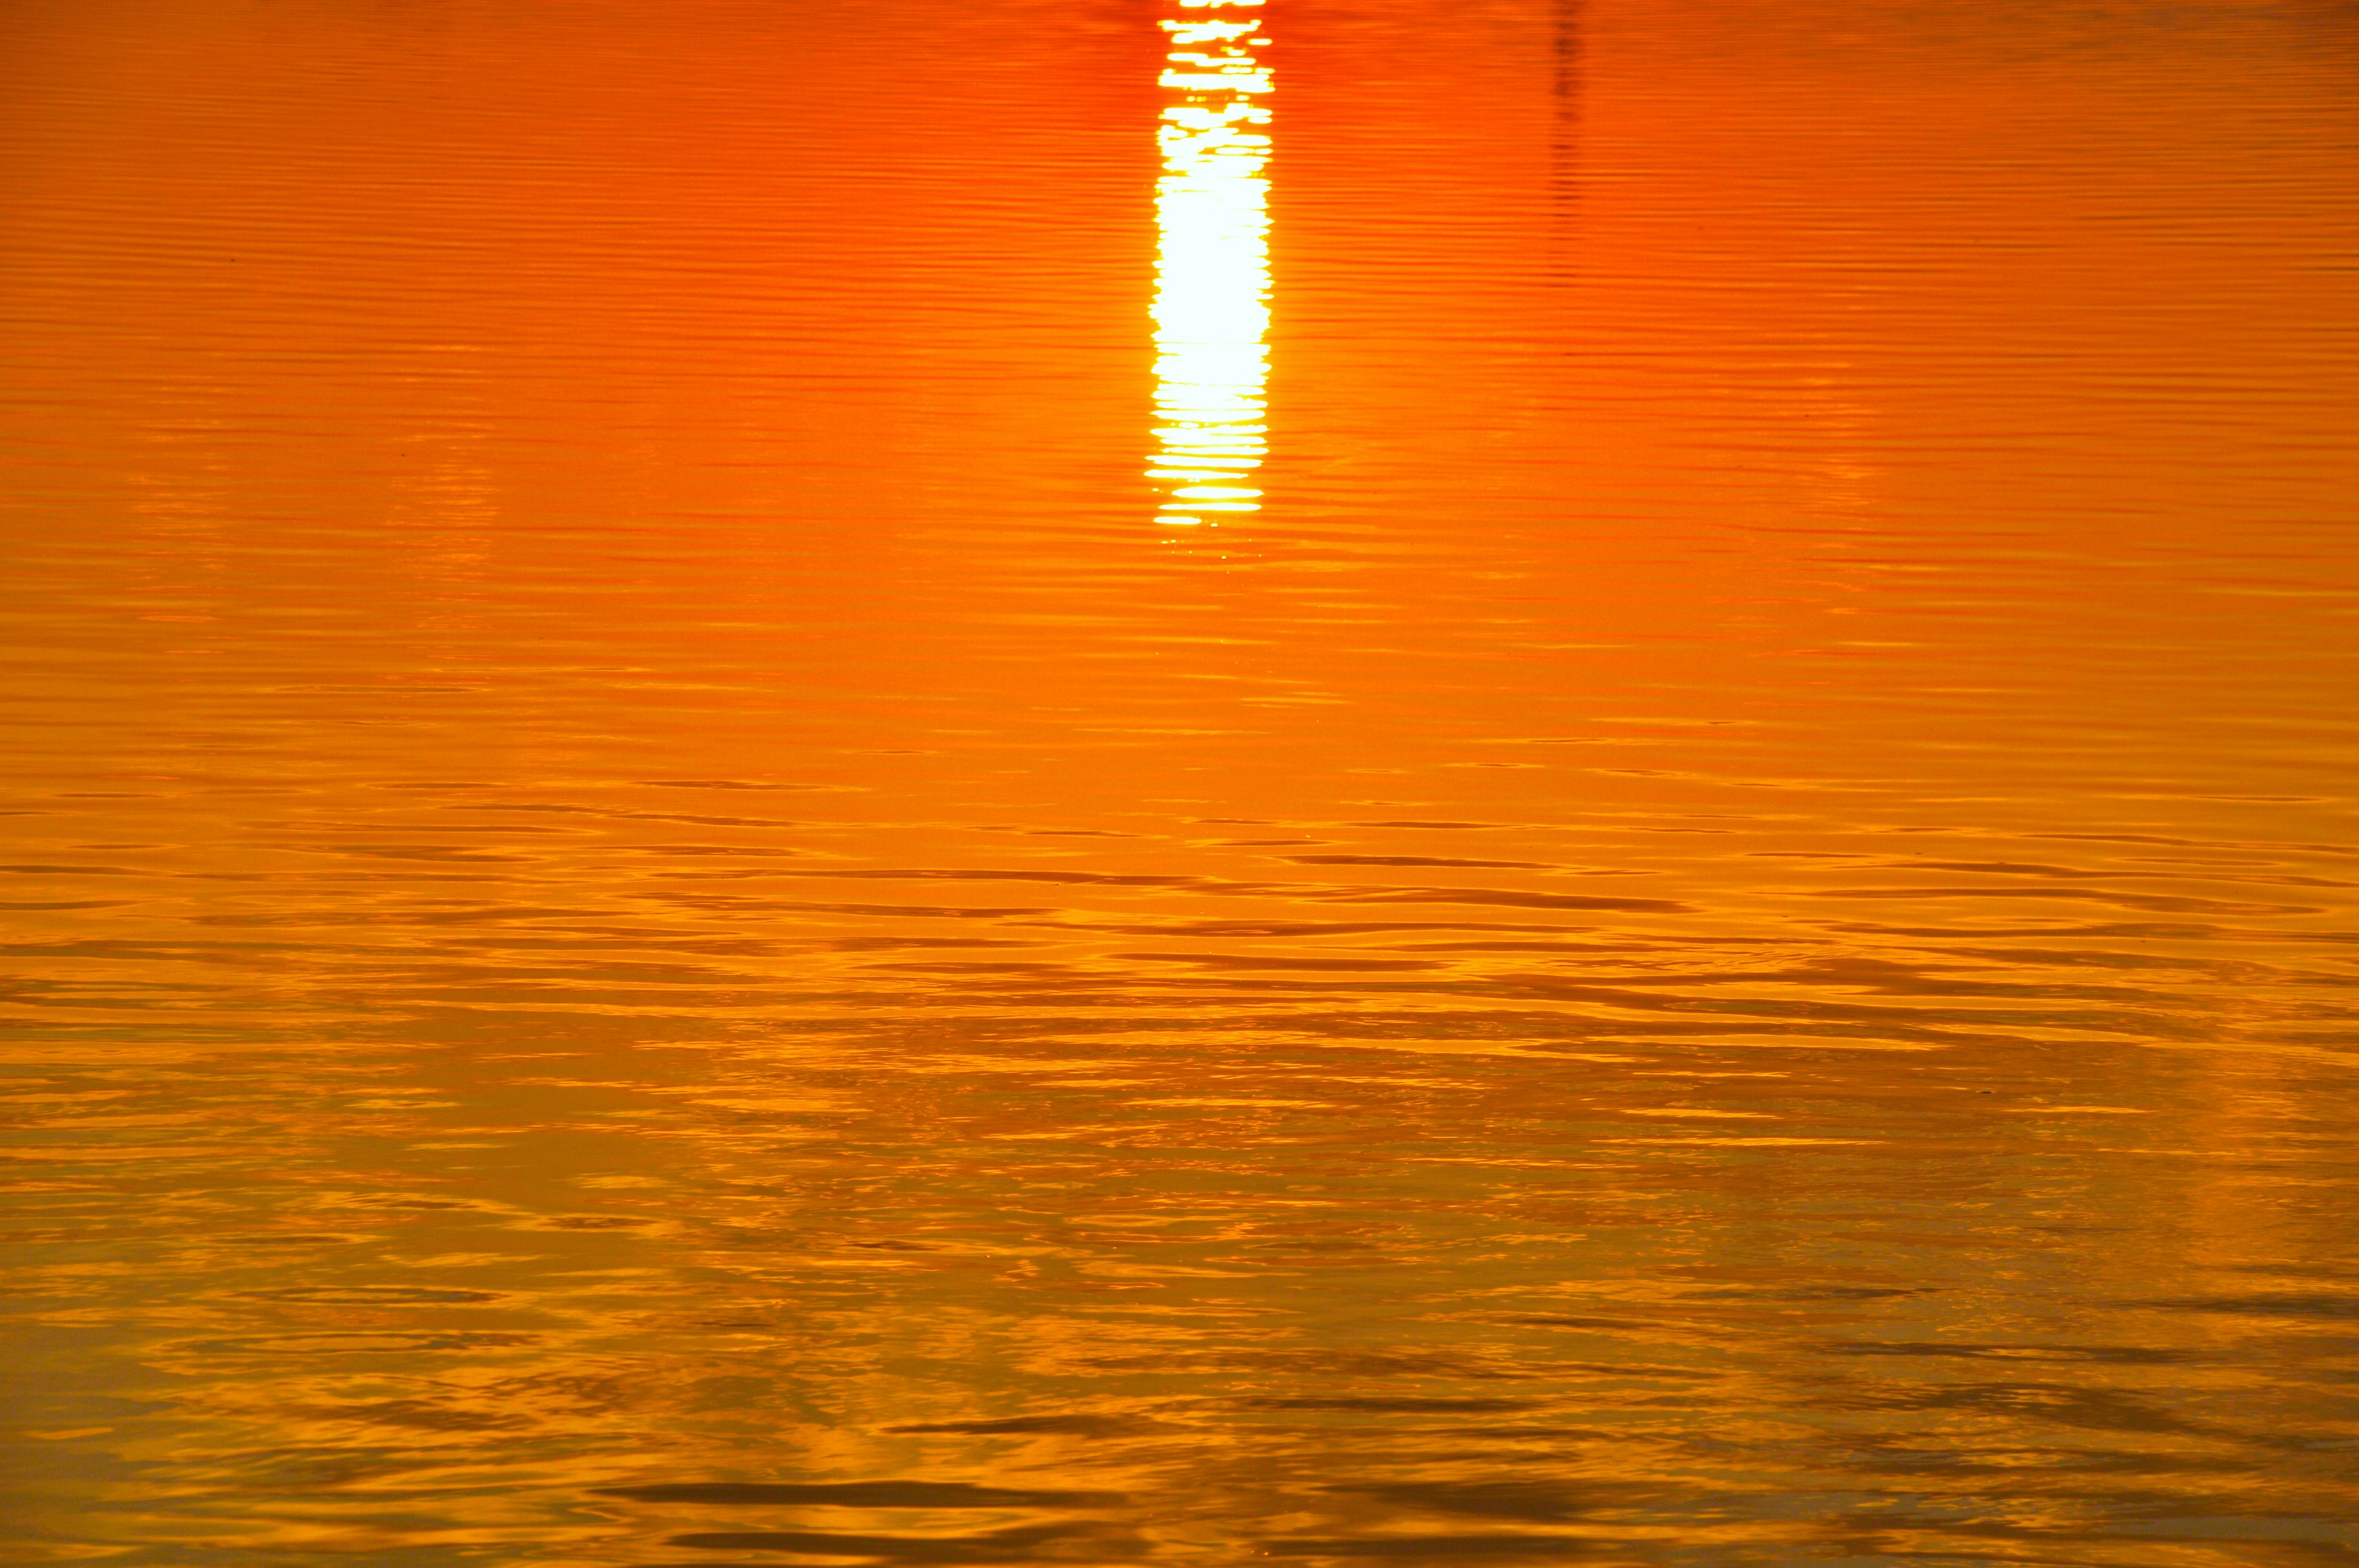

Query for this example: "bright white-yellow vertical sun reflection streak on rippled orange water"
[1146,0,1269,528]
